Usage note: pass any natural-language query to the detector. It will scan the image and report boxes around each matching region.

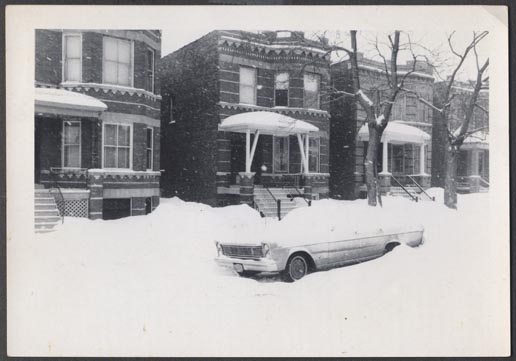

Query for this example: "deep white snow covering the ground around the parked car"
[8,189,508,356]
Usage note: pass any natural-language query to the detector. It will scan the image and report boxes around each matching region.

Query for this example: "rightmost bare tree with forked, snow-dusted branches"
[403,31,489,209]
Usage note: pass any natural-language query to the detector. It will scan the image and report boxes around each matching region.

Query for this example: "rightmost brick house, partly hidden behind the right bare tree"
[432,81,489,192]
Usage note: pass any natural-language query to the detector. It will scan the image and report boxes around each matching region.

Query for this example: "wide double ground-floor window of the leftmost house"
[104,124,131,169]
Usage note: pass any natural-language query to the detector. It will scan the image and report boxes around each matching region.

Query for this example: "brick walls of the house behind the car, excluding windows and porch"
[160,31,330,205]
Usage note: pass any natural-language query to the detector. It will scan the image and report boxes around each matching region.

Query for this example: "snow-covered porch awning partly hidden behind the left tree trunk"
[358,121,431,144]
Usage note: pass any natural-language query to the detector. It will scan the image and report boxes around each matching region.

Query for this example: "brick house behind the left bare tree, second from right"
[330,53,434,199]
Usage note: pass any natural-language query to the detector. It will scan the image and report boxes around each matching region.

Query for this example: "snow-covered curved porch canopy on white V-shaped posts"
[219,112,319,135]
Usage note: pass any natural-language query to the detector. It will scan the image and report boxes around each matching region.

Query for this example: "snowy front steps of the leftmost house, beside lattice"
[34,187,61,233]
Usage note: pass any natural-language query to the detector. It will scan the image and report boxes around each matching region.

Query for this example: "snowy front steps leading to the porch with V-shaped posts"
[254,187,306,218]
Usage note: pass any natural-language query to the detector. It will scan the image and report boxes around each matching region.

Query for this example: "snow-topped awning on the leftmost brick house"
[34,88,107,117]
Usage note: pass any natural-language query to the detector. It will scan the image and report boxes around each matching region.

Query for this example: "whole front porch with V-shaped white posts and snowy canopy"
[217,111,328,215]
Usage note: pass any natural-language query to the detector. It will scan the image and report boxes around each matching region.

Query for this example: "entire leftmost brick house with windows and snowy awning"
[34,30,161,229]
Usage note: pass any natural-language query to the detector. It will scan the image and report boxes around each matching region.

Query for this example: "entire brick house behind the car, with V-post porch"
[159,31,330,213]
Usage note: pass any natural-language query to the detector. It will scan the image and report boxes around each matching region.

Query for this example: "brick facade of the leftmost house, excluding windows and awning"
[35,30,161,219]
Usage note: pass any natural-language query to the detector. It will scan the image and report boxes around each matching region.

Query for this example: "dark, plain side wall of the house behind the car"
[159,33,219,205]
